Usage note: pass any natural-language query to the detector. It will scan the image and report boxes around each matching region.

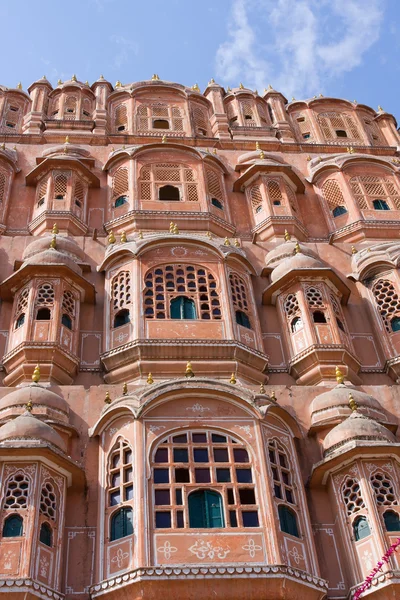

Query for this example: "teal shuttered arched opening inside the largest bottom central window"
[188,490,225,529]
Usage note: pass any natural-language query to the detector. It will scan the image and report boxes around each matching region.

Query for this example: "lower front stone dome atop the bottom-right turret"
[323,410,397,454]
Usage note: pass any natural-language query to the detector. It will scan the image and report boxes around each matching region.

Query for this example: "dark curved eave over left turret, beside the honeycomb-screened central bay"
[0,263,96,304]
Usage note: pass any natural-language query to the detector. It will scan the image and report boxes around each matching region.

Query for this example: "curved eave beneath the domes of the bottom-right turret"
[309,440,400,488]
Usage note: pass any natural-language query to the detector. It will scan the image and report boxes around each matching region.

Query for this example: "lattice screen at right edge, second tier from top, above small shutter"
[350,175,400,210]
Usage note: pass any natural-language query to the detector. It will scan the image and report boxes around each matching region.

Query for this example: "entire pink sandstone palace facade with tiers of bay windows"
[0,75,400,600]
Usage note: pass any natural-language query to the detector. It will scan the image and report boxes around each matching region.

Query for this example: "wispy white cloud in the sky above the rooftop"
[216,0,383,97]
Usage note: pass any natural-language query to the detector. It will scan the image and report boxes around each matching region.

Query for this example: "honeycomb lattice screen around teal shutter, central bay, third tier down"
[144,264,221,320]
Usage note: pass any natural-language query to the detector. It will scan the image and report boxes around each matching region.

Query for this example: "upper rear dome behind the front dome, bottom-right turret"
[311,384,387,426]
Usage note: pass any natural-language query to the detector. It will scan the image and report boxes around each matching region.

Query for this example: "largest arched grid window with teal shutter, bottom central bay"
[152,430,259,529]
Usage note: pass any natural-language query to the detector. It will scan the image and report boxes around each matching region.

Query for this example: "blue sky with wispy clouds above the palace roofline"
[0,0,400,121]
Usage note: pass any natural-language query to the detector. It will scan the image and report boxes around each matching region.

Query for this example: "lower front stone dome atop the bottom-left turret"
[0,412,67,452]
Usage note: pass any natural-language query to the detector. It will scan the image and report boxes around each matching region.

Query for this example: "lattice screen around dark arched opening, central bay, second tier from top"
[139,163,199,202]
